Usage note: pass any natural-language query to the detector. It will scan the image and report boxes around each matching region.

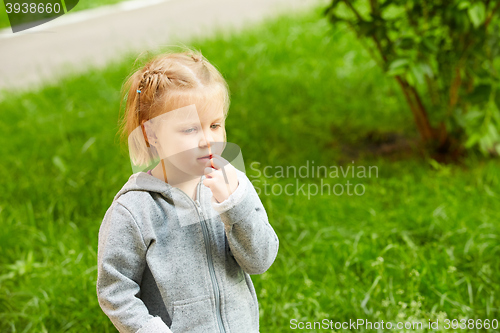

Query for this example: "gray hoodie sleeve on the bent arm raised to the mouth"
[212,170,279,274]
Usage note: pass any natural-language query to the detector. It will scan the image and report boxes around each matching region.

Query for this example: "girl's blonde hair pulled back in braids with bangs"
[119,47,230,165]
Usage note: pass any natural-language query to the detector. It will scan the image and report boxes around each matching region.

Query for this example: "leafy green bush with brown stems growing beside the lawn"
[325,0,500,158]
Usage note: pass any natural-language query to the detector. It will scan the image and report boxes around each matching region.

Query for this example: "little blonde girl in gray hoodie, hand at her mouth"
[96,49,279,333]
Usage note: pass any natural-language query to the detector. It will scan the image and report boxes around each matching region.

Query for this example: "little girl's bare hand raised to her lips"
[203,154,239,203]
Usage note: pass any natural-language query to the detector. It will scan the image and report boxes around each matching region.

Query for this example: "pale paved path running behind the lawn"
[0,0,328,90]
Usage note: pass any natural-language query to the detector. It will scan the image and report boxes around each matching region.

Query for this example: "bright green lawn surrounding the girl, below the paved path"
[0,3,500,332]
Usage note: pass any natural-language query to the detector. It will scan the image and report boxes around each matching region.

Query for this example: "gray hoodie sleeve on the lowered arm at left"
[96,201,172,333]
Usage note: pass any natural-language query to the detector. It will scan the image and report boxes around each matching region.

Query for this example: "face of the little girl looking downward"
[149,104,225,176]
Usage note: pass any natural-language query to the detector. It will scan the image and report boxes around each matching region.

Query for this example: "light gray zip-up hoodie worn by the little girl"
[96,169,279,333]
